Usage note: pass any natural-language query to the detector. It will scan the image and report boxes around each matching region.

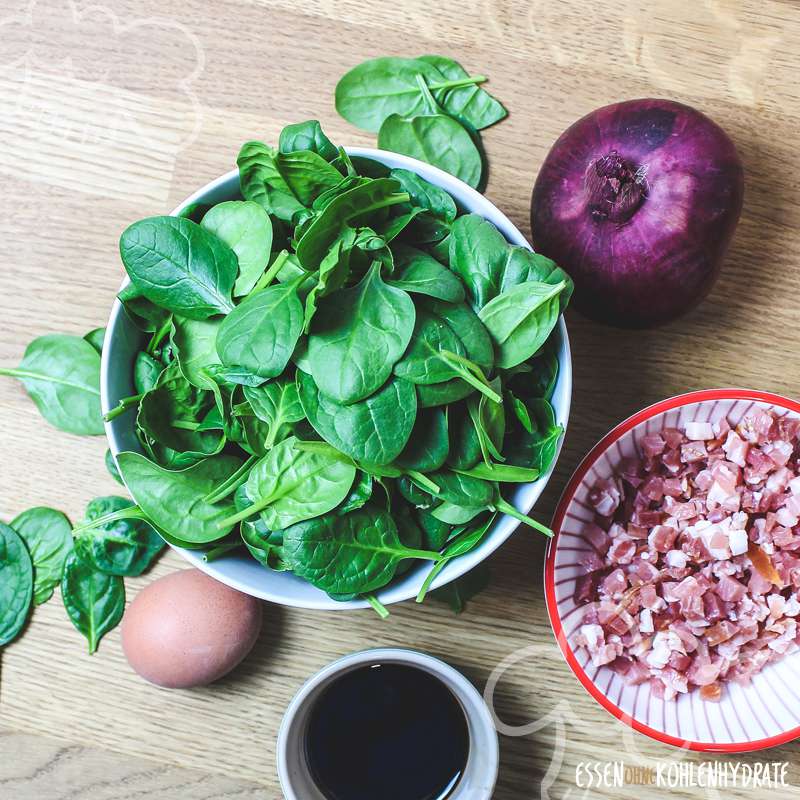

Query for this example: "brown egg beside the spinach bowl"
[122,569,261,689]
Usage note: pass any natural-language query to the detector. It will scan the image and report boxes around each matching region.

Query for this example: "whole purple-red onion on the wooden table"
[531,99,744,328]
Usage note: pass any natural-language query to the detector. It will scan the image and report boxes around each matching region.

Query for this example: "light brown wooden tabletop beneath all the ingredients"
[0,0,800,800]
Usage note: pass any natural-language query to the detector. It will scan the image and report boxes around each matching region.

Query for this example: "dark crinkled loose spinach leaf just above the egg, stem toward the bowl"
[75,496,164,576]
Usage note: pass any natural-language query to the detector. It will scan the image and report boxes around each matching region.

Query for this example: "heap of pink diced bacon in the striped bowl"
[575,408,800,701]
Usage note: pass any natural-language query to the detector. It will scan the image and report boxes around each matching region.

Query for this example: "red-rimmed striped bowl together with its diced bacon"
[545,389,800,752]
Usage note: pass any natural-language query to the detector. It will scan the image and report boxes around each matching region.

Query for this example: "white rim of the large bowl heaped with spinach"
[100,147,572,611]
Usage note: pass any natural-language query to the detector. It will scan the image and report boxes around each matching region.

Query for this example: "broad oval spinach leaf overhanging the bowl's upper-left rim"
[119,217,238,319]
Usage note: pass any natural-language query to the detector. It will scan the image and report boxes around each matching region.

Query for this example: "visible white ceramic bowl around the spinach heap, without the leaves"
[100,147,572,611]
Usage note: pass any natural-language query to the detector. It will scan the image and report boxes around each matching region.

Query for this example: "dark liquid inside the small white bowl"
[305,664,469,800]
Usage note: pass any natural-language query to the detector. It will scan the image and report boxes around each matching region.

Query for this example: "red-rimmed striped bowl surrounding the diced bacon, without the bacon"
[545,389,800,753]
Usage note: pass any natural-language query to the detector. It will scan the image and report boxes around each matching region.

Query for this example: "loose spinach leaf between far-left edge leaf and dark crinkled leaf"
[10,506,72,606]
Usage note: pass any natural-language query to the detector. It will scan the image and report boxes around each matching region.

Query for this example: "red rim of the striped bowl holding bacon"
[544,387,800,753]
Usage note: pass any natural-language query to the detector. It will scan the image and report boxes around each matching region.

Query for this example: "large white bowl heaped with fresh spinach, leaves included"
[100,121,572,613]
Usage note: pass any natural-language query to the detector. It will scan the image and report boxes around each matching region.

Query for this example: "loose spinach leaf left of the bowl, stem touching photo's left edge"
[0,333,103,436]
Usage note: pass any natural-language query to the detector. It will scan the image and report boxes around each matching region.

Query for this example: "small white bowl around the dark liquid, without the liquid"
[277,647,499,800]
